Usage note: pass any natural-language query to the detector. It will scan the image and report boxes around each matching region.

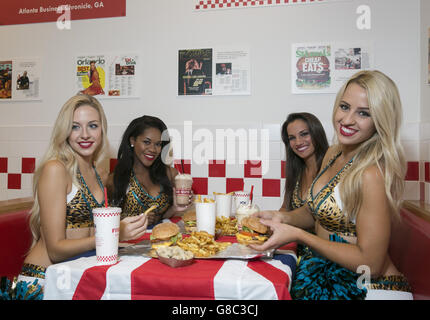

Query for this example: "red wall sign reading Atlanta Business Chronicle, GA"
[0,0,126,26]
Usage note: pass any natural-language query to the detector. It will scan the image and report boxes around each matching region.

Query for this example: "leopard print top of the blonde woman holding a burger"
[306,152,357,237]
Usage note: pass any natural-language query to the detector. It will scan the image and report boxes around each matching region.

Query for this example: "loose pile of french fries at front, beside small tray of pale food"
[177,231,231,258]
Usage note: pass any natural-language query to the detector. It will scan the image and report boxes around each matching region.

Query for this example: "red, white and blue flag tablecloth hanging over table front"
[44,218,296,300]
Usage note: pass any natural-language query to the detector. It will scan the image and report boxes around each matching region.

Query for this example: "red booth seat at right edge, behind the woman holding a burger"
[389,209,430,300]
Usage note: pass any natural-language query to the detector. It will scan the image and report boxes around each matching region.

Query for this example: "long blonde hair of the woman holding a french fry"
[30,94,108,245]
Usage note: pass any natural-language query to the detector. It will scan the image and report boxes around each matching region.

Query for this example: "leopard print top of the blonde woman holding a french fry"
[66,168,104,229]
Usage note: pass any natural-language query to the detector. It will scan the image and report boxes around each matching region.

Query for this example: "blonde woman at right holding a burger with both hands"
[254,71,412,299]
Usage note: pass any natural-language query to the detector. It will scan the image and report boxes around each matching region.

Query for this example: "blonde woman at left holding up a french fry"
[2,95,125,298]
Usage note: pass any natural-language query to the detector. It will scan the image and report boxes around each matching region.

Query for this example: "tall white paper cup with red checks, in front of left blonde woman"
[93,207,121,265]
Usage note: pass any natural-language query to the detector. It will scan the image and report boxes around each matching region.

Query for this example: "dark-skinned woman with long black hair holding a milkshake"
[107,115,192,239]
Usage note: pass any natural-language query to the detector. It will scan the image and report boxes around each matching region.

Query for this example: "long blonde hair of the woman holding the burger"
[332,70,406,220]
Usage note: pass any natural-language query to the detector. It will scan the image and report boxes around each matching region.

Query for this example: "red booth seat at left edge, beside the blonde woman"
[0,210,32,278]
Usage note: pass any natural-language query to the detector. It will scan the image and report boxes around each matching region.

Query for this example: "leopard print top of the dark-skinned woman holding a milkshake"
[121,171,171,223]
